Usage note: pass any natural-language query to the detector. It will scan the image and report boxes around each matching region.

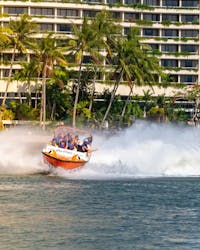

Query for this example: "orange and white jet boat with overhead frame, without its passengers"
[42,126,92,170]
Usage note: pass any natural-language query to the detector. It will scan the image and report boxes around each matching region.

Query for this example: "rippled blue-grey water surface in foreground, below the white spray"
[0,175,200,250]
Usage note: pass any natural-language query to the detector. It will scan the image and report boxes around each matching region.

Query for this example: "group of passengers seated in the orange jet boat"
[51,133,92,152]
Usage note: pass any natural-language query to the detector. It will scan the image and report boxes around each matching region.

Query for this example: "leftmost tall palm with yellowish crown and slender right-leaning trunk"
[2,14,37,106]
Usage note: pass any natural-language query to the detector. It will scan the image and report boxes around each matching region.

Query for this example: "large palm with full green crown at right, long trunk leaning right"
[101,28,160,126]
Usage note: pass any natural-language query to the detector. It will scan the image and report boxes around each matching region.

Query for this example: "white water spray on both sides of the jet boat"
[0,122,200,179]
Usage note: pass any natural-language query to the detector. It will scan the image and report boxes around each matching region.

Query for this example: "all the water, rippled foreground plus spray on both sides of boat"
[0,122,200,250]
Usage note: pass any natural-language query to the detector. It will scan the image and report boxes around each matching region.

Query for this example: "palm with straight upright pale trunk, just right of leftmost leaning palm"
[35,33,67,129]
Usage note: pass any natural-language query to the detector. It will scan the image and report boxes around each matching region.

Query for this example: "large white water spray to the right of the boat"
[59,122,200,179]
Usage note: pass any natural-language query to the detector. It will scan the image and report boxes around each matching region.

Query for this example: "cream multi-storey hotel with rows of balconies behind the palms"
[0,0,200,101]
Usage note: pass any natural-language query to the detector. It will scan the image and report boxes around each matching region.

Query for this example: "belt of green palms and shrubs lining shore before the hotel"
[0,11,196,129]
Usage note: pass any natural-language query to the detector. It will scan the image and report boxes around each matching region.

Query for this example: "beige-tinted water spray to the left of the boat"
[0,127,49,175]
